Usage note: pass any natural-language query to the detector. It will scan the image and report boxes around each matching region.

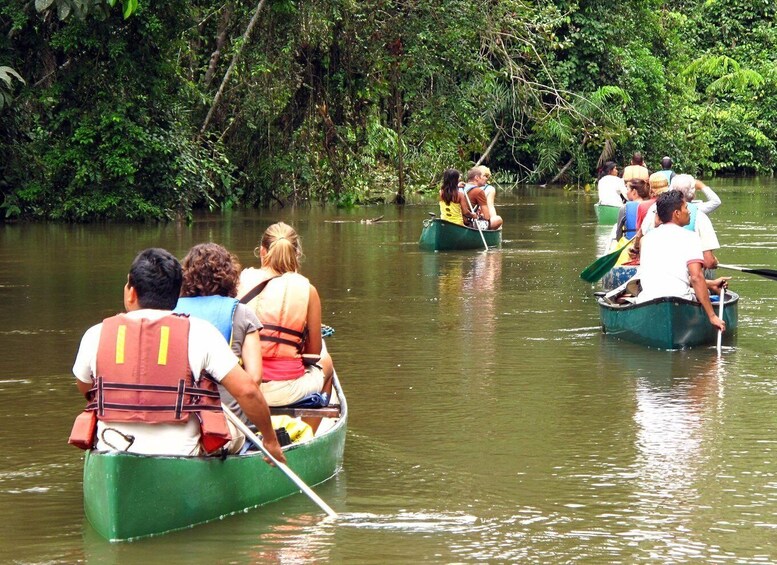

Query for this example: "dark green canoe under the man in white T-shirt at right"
[597,291,739,349]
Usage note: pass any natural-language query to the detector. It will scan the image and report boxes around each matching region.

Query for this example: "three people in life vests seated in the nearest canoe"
[70,222,334,462]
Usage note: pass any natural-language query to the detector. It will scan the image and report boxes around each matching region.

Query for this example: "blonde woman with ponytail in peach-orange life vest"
[238,222,334,406]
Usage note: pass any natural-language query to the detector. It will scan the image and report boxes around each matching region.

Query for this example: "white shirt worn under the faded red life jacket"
[73,309,238,455]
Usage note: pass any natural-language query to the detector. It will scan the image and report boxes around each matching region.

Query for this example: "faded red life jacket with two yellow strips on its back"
[70,314,231,453]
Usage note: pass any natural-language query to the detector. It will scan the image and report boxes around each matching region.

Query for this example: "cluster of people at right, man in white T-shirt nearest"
[597,153,729,331]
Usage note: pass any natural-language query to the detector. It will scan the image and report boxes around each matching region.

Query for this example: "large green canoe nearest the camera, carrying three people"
[84,376,347,541]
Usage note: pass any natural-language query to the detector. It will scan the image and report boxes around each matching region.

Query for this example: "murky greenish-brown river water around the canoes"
[0,179,777,564]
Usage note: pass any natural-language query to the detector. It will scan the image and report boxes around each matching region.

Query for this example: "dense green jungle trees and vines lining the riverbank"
[0,0,777,221]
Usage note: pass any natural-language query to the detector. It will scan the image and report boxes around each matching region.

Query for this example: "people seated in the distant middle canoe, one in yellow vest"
[440,165,502,230]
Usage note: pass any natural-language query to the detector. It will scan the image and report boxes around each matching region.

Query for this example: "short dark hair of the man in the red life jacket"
[128,247,183,310]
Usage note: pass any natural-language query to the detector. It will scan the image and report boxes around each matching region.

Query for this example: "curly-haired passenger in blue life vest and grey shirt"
[173,243,262,423]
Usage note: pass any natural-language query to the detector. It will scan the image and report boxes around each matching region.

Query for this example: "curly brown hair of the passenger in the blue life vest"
[181,243,240,297]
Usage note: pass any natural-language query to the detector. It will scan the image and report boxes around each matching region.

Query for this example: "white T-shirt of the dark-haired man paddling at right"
[637,223,704,303]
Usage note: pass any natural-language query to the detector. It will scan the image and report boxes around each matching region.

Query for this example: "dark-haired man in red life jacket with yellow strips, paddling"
[71,249,286,462]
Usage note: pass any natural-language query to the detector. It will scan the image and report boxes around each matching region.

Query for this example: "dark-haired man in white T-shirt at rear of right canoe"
[637,191,728,331]
